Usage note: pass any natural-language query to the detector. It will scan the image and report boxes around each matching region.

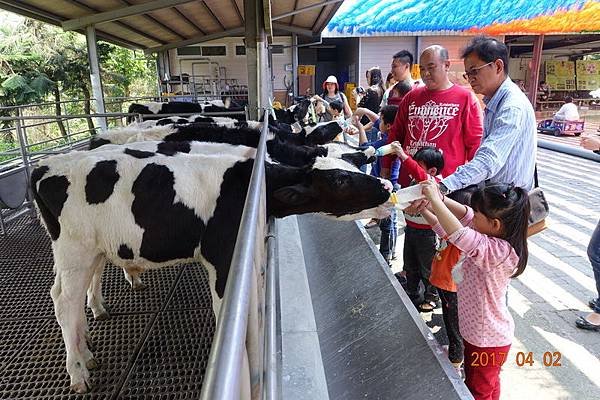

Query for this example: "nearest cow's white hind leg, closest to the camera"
[50,246,101,393]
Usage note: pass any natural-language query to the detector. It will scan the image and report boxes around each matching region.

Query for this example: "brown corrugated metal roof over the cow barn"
[0,0,342,50]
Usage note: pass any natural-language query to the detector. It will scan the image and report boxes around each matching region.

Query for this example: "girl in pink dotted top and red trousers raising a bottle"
[421,181,529,400]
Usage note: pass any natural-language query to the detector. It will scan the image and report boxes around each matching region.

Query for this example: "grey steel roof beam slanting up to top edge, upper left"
[62,0,195,31]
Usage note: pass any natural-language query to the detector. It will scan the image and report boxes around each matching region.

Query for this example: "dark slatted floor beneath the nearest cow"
[0,216,214,400]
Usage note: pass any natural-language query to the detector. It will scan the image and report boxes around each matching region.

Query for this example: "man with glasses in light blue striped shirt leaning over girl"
[440,36,537,193]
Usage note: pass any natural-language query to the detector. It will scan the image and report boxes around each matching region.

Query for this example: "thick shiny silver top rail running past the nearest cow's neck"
[200,110,268,400]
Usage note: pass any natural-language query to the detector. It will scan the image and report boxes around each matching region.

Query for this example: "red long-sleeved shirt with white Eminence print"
[382,85,483,187]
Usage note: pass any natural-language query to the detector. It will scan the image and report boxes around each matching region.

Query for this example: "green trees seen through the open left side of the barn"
[0,11,155,143]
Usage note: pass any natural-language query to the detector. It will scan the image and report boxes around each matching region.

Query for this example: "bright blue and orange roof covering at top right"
[323,0,600,37]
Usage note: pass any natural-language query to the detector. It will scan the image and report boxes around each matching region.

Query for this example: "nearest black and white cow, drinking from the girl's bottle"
[31,146,392,393]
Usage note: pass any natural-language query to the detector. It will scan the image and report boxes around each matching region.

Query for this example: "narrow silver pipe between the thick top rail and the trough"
[264,220,281,400]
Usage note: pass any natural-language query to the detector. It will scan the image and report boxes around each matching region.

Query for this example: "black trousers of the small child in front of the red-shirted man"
[404,226,438,304]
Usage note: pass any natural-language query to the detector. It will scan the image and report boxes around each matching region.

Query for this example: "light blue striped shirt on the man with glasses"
[442,77,537,191]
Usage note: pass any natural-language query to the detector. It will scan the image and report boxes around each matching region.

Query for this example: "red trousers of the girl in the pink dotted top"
[464,341,510,400]
